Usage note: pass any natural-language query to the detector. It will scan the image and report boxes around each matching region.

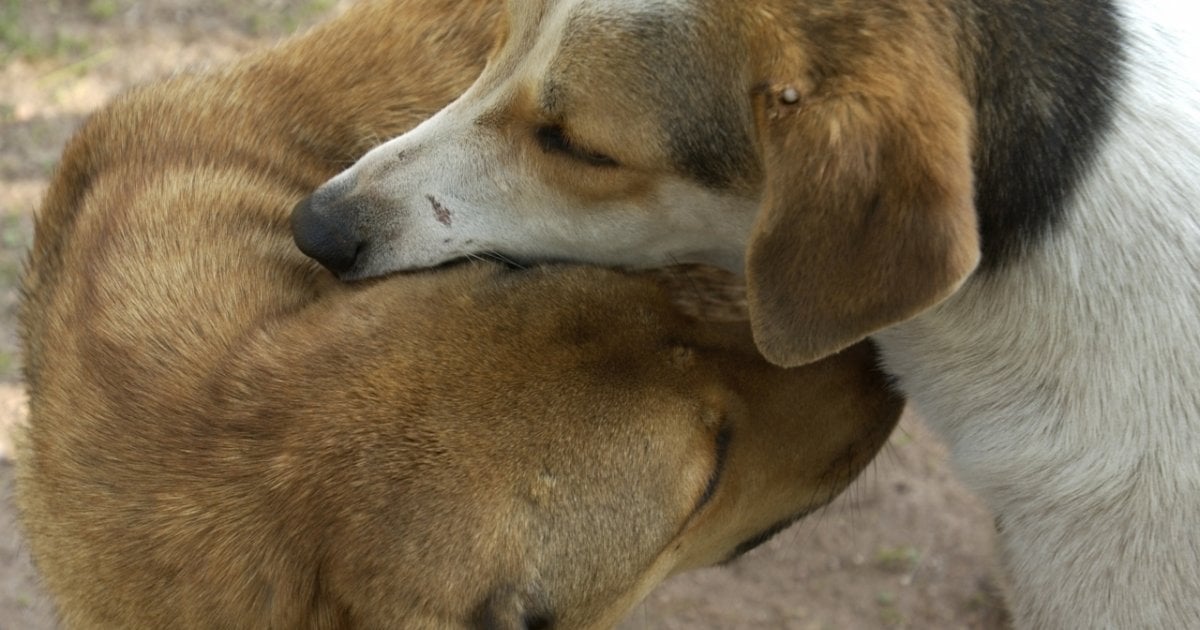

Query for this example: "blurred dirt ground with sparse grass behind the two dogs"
[0,0,1007,630]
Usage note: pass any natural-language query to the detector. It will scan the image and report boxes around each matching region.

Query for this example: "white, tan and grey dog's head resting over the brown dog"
[293,0,979,365]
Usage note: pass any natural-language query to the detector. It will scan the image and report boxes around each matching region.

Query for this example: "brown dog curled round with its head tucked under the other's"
[18,0,901,629]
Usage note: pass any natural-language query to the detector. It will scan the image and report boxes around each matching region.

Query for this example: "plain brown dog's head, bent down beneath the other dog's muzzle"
[283,266,902,629]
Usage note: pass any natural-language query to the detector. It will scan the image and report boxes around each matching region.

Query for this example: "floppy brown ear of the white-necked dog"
[746,79,979,366]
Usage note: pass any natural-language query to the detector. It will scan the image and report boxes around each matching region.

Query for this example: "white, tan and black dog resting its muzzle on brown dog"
[293,0,1200,628]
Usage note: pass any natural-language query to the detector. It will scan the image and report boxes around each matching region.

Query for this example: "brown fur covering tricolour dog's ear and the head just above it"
[746,0,979,365]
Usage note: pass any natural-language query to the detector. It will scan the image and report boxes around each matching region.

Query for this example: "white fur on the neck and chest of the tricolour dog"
[877,2,1200,629]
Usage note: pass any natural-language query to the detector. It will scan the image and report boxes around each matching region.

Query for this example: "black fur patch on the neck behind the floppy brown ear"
[966,0,1124,267]
